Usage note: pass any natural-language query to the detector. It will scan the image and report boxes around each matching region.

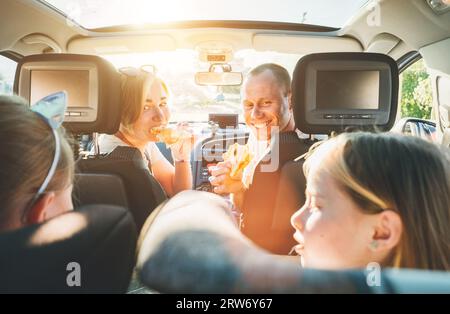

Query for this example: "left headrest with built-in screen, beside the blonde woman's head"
[14,54,121,134]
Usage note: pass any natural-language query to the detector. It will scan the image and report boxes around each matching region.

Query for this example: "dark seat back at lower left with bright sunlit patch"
[0,205,137,293]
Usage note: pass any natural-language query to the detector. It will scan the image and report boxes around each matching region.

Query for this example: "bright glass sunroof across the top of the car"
[39,0,367,29]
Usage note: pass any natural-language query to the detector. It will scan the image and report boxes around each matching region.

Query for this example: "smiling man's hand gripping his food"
[209,162,245,195]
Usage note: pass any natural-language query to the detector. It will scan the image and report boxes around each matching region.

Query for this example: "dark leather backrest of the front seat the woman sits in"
[77,146,167,231]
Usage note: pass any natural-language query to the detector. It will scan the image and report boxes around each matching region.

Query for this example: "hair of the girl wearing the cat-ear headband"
[0,96,74,230]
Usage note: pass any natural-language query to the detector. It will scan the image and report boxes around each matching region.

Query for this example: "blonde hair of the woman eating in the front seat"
[121,71,169,131]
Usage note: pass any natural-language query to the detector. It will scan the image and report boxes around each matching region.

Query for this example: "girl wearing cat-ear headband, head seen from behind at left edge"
[0,95,74,231]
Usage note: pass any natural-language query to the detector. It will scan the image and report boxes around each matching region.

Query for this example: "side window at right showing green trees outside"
[400,59,433,119]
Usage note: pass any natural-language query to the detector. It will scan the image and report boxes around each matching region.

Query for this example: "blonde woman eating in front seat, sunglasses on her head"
[99,67,193,196]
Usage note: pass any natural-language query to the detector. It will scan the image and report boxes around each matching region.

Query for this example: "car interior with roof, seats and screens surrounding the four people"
[0,0,450,293]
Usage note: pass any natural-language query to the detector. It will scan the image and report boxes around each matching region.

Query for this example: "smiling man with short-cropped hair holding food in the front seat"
[211,63,295,197]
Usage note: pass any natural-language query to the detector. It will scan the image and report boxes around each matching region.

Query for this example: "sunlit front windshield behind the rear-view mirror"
[103,50,301,122]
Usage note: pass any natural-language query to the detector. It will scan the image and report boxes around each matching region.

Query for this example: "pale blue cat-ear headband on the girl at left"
[23,91,67,220]
